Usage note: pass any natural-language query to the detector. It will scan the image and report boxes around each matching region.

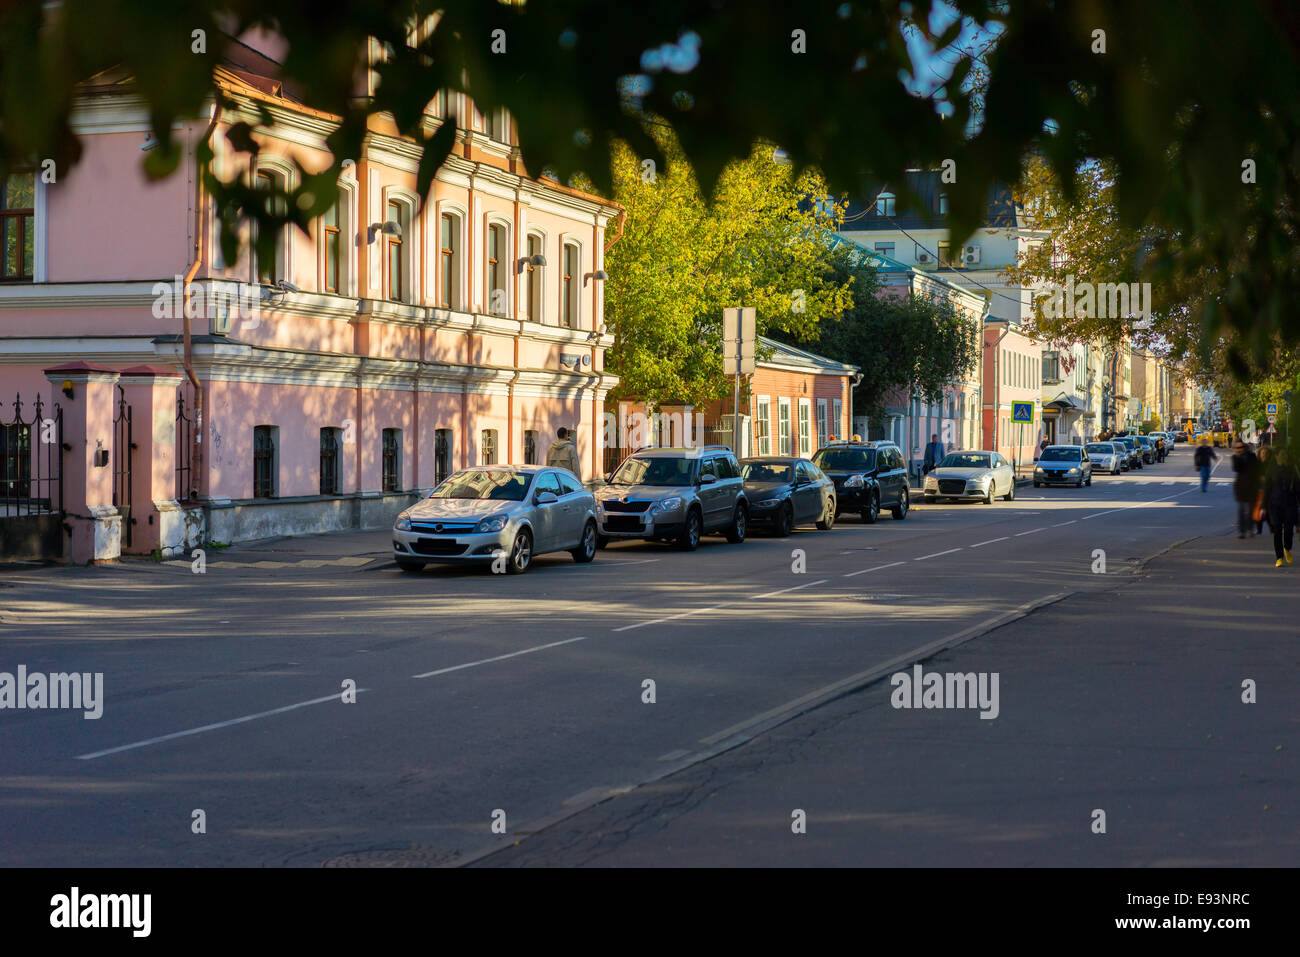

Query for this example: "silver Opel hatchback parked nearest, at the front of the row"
[393,465,597,575]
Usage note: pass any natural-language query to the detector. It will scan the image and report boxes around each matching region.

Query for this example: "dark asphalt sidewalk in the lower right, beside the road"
[484,523,1300,867]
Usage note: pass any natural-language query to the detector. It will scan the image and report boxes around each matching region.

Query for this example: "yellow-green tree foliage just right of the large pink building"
[605,126,853,404]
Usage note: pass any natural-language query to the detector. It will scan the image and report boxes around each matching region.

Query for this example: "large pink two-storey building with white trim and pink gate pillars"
[0,38,621,560]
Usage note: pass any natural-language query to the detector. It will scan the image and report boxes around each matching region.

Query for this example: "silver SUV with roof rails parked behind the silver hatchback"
[595,445,749,551]
